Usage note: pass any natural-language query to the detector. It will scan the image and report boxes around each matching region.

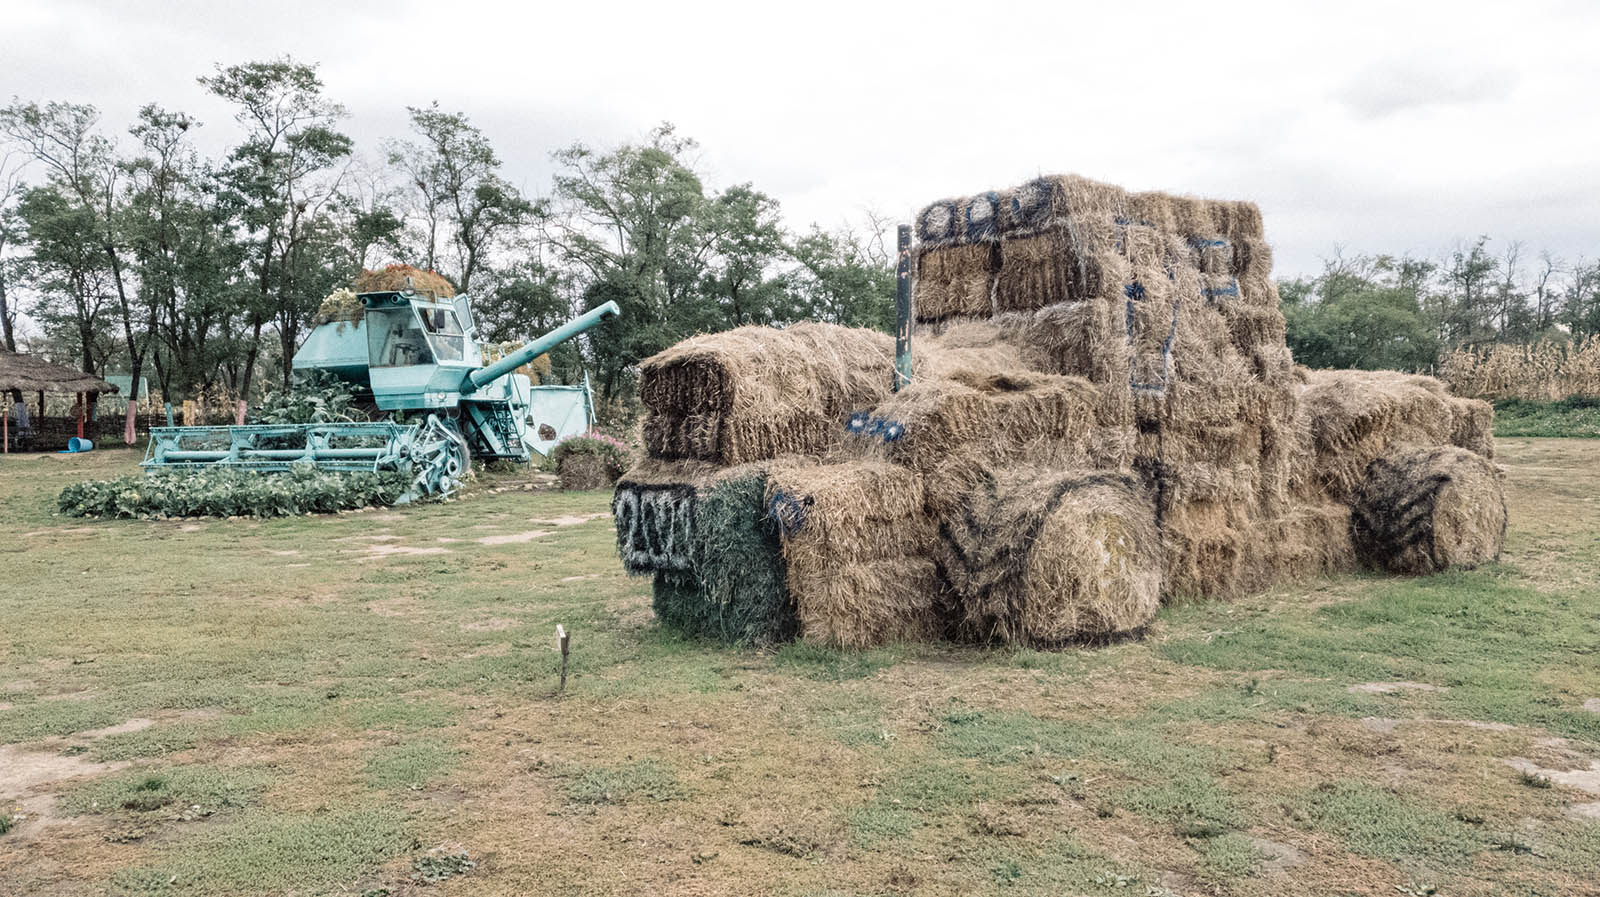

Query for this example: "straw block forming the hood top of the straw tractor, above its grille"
[640,323,894,465]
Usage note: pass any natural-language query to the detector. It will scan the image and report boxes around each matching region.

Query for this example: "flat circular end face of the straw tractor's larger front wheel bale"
[1019,486,1162,646]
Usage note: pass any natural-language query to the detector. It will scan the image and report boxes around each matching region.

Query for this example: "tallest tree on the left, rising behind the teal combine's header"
[200,56,354,393]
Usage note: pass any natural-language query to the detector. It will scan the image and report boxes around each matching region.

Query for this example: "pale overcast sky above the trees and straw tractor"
[0,0,1600,275]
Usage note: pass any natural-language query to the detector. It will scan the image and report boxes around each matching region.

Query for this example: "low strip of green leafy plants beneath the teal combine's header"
[56,468,410,520]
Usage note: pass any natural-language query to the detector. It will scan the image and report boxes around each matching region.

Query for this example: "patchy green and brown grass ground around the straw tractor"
[0,440,1600,897]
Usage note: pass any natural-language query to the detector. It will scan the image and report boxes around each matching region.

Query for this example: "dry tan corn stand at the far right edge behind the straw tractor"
[1438,337,1600,401]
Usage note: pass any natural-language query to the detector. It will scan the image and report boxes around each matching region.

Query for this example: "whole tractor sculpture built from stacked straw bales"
[613,176,1506,648]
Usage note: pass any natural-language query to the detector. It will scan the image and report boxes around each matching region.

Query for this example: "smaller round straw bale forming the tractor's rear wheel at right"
[1350,446,1506,574]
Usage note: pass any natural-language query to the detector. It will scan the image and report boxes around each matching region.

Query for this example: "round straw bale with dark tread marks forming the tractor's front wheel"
[936,468,1162,648]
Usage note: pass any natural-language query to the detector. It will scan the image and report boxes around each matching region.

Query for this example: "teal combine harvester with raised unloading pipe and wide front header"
[142,289,621,500]
